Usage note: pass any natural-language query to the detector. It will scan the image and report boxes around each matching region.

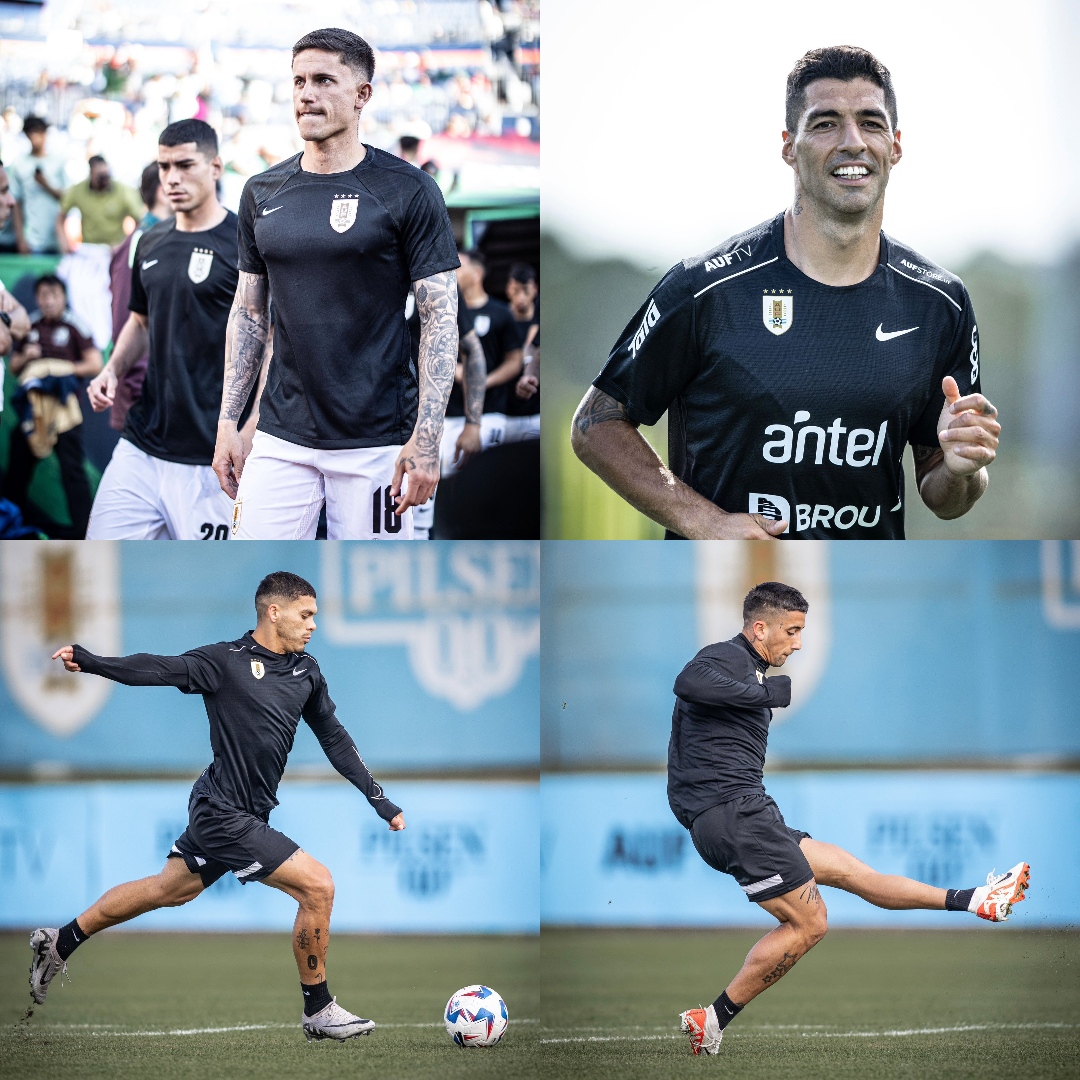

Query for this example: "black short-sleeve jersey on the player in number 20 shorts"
[123,211,249,465]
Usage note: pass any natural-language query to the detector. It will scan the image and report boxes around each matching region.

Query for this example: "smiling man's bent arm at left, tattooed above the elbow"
[570,387,787,540]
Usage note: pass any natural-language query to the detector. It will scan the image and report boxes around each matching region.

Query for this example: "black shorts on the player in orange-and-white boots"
[690,795,813,904]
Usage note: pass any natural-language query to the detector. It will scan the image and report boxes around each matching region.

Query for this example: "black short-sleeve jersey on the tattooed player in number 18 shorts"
[240,147,459,450]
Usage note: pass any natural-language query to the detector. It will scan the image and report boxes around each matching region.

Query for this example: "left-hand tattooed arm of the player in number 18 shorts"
[214,271,270,499]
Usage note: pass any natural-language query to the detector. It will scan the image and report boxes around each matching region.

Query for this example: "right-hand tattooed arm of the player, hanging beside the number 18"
[390,270,458,514]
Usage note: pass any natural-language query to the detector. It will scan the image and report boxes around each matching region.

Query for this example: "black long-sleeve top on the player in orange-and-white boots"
[667,634,792,828]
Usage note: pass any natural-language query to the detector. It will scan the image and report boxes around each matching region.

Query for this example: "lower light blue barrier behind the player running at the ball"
[0,781,539,933]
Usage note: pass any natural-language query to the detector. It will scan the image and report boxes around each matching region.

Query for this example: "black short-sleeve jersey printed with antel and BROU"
[595,214,980,539]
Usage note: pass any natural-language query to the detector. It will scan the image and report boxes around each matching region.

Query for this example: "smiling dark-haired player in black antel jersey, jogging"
[571,46,1001,539]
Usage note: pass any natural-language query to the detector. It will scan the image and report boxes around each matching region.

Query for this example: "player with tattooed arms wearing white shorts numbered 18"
[214,29,458,540]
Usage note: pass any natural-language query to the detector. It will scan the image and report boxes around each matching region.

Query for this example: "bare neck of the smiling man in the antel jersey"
[784,199,883,285]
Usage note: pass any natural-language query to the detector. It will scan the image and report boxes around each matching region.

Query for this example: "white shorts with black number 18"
[232,431,413,540]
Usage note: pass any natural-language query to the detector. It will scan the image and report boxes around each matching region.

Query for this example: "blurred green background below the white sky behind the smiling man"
[541,233,1080,540]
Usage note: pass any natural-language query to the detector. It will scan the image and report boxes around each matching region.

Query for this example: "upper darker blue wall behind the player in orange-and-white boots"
[541,541,1080,769]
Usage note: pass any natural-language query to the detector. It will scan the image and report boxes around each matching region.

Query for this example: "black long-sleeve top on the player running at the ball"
[73,631,401,821]
